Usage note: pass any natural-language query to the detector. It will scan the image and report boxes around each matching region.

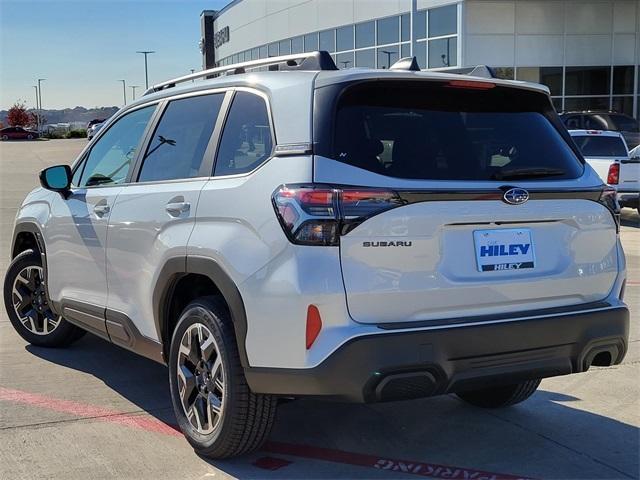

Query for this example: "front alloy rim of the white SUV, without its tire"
[12,266,62,335]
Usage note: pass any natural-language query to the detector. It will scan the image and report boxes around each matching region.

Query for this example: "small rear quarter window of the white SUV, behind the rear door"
[214,92,273,176]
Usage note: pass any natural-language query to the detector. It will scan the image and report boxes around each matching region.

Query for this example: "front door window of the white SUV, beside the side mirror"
[74,105,156,187]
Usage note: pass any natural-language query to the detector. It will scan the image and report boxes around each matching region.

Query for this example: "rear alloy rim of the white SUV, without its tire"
[177,323,225,435]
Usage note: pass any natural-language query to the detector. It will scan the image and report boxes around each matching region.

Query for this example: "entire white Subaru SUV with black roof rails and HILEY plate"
[4,52,629,457]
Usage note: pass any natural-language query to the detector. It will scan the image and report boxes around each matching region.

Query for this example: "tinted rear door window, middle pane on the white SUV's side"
[138,93,224,182]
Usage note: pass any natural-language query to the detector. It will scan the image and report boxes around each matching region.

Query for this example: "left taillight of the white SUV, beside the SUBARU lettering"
[273,185,404,246]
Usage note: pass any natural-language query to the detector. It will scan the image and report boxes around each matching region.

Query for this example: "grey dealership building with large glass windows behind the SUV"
[201,0,640,118]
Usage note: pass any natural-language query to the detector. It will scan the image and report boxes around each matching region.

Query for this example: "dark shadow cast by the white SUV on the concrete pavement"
[26,335,640,479]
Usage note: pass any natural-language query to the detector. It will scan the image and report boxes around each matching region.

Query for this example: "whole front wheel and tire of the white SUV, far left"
[4,250,86,348]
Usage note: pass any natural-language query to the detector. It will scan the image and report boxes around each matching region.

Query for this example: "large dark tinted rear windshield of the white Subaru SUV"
[330,81,583,180]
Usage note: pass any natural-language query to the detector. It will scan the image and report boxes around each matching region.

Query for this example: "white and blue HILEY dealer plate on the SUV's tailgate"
[473,228,535,272]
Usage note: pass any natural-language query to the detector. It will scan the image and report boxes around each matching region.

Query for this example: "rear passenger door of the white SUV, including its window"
[107,91,230,338]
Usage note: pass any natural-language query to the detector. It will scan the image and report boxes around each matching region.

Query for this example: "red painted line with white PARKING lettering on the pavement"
[0,387,525,480]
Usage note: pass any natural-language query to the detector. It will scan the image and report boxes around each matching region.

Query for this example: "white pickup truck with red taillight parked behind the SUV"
[569,130,640,212]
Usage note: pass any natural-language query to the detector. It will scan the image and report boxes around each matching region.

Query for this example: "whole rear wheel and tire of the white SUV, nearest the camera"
[169,297,277,458]
